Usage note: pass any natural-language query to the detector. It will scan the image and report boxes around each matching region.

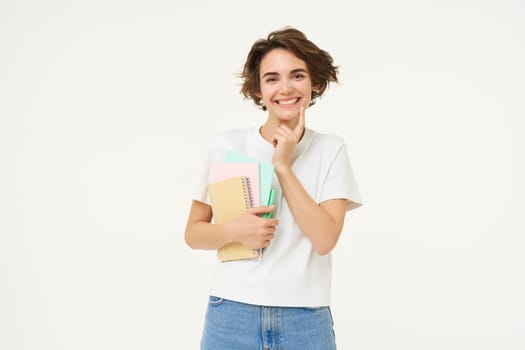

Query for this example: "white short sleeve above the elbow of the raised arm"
[319,142,362,211]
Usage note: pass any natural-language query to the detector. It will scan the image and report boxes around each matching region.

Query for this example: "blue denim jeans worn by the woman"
[201,296,336,350]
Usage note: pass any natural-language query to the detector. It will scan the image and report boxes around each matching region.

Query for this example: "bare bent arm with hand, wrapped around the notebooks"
[184,200,278,250]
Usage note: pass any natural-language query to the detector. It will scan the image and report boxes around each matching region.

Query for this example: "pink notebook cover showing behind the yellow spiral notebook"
[210,163,261,207]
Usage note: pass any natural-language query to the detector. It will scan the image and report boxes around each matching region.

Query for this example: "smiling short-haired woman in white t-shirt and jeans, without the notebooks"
[185,28,361,350]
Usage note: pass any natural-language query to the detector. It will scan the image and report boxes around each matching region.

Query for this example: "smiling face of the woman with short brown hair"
[257,49,312,122]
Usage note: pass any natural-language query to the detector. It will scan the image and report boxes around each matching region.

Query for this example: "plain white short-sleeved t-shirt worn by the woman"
[193,127,361,307]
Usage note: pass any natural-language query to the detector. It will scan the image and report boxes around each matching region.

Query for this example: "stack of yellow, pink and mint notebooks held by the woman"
[208,151,275,262]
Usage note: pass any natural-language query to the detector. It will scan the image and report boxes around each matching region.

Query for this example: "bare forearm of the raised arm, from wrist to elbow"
[276,167,342,255]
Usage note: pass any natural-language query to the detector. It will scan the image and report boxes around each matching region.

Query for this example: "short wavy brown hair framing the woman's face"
[240,27,338,110]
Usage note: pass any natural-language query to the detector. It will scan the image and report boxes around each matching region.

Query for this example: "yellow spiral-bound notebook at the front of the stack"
[208,176,259,262]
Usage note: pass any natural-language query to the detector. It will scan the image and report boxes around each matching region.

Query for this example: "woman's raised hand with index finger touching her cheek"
[272,106,305,171]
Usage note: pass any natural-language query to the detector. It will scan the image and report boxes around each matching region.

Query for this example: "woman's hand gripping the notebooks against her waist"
[225,206,279,249]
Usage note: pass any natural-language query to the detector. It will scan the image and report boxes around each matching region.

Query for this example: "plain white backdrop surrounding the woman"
[0,0,525,350]
